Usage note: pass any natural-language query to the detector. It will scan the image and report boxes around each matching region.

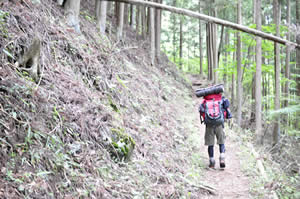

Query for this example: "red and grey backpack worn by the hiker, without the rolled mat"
[199,93,225,126]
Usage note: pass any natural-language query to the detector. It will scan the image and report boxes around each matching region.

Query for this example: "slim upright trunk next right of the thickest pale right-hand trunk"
[273,0,281,145]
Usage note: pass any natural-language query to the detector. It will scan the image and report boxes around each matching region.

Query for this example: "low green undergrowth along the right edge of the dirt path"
[232,126,300,199]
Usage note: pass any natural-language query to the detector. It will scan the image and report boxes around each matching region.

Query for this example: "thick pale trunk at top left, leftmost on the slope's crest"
[64,0,81,33]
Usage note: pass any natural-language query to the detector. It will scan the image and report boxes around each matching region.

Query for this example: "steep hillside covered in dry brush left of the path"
[0,0,212,198]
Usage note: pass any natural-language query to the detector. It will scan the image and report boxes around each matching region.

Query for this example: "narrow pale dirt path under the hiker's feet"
[194,76,252,199]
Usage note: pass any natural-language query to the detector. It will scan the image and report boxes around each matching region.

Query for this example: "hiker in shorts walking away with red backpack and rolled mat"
[196,85,232,169]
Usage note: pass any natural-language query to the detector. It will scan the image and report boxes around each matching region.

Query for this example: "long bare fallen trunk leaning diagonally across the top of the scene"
[113,0,300,48]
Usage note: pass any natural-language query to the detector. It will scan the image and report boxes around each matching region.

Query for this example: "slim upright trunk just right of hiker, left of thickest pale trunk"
[236,0,243,126]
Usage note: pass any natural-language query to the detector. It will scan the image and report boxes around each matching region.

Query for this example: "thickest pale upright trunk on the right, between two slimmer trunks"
[255,0,263,144]
